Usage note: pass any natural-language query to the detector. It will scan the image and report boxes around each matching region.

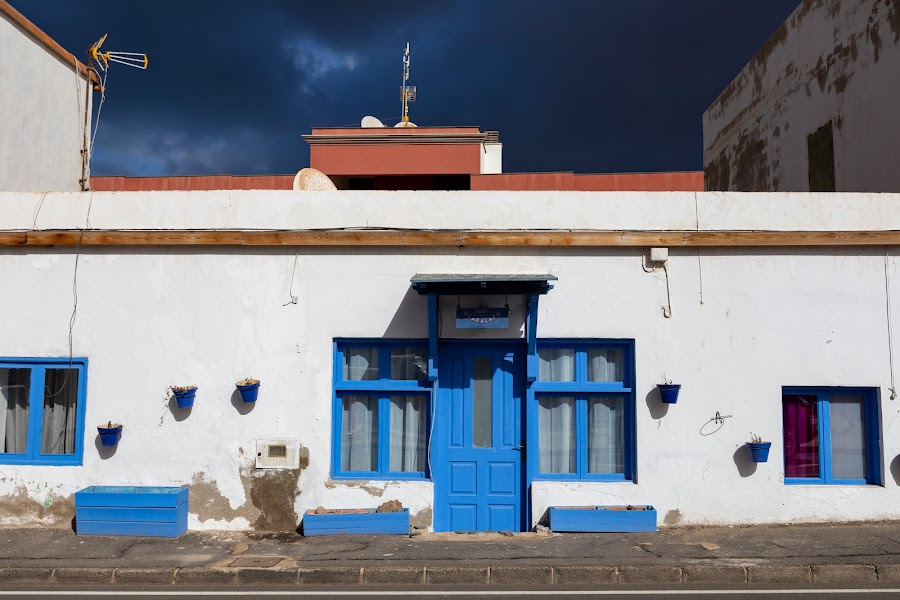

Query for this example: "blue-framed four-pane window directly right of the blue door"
[527,339,635,481]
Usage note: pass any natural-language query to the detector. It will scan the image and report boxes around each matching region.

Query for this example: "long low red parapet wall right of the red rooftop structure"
[472,171,703,192]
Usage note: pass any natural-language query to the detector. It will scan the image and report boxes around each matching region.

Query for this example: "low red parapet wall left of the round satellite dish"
[91,175,294,192]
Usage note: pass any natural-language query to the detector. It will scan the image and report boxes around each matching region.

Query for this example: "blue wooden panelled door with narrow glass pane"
[432,343,525,531]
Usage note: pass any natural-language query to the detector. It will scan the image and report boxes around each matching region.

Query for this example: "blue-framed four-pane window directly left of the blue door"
[331,340,433,479]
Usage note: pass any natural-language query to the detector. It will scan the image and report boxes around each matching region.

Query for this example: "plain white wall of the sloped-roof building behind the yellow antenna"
[0,13,90,192]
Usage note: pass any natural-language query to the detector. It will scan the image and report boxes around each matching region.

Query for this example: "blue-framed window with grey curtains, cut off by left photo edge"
[0,358,87,465]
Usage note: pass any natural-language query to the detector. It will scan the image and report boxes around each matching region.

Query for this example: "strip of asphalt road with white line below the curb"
[0,584,900,600]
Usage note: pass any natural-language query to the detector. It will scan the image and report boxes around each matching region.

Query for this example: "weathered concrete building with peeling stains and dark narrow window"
[703,0,900,192]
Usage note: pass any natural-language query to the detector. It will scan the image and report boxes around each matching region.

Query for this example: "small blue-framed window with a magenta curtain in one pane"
[781,387,881,485]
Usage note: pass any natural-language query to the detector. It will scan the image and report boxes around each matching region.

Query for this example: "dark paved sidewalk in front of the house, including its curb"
[0,522,900,587]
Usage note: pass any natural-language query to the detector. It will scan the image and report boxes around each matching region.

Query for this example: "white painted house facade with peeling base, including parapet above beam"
[0,192,900,529]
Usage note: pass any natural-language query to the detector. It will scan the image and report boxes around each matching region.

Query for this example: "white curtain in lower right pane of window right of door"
[588,397,625,473]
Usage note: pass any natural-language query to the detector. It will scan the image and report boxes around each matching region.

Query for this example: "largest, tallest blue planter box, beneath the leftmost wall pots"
[75,485,188,537]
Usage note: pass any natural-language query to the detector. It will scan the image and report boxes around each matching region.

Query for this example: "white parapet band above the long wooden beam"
[0,190,900,231]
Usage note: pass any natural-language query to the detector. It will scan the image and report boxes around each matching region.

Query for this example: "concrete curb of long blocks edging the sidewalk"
[0,564,900,586]
